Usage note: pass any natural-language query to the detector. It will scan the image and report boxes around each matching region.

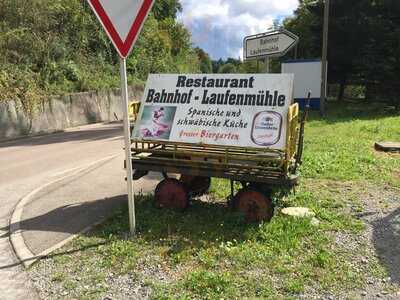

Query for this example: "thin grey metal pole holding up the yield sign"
[121,58,136,235]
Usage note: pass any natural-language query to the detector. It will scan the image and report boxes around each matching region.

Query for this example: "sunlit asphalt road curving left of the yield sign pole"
[0,124,135,299]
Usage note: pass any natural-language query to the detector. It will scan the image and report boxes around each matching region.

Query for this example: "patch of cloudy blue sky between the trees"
[179,0,298,59]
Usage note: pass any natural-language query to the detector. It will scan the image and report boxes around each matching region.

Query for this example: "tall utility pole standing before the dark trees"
[321,0,329,115]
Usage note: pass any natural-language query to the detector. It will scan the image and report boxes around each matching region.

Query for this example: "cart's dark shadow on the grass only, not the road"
[82,195,253,256]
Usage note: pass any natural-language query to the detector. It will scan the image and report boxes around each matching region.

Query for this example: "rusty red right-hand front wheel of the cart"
[233,188,274,222]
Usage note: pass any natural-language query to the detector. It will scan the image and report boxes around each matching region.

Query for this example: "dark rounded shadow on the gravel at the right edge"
[372,208,400,284]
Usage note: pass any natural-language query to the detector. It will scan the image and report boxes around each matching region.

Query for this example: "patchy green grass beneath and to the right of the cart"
[31,102,400,299]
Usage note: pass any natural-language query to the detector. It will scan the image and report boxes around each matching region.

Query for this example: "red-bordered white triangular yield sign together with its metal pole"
[87,0,155,234]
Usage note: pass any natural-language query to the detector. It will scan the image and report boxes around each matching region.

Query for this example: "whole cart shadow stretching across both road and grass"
[0,195,255,269]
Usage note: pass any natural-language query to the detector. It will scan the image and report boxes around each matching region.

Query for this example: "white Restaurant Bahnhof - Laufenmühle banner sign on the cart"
[133,74,293,150]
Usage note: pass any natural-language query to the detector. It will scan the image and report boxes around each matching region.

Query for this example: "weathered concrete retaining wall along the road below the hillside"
[0,86,143,140]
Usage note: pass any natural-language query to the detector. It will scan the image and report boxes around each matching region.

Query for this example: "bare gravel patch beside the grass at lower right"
[335,183,400,300]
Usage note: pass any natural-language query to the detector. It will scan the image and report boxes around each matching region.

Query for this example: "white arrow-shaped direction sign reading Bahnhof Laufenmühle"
[243,29,299,60]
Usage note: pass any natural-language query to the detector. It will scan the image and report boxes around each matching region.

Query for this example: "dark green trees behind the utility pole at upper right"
[284,0,400,108]
